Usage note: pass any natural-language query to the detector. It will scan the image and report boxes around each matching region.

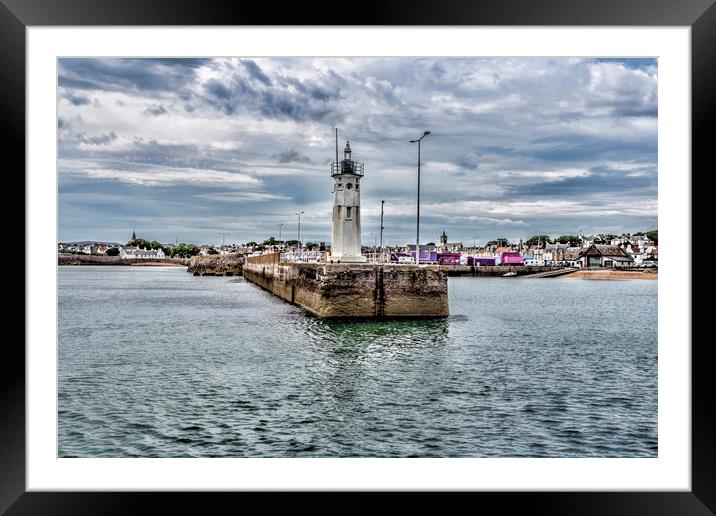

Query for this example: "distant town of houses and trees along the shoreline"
[57,230,659,269]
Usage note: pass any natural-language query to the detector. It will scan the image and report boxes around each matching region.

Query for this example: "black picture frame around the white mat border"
[0,0,716,515]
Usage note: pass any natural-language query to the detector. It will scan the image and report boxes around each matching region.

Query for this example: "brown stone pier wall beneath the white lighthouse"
[243,254,449,318]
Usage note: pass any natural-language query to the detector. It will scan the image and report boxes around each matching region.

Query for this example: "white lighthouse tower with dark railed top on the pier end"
[328,142,366,263]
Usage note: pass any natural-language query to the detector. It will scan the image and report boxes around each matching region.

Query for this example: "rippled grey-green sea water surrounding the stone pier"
[58,266,657,457]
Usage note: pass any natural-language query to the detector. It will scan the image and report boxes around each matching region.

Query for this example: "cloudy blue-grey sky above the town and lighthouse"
[58,58,657,244]
